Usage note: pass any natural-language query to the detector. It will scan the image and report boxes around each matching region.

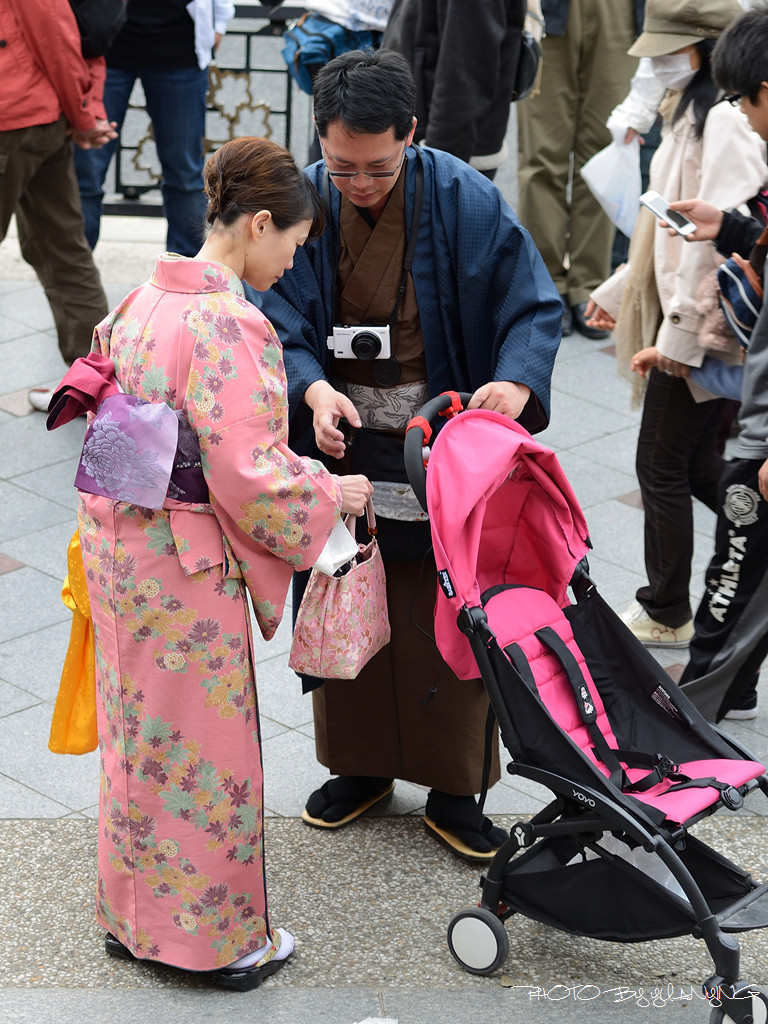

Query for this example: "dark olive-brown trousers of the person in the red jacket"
[0,117,108,364]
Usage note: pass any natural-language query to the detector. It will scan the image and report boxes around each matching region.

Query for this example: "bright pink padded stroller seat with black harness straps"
[483,585,765,824]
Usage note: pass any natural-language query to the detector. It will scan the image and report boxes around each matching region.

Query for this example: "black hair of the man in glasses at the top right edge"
[712,3,768,103]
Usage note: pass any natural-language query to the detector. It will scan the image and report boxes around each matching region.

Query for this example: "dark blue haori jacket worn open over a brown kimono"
[248,146,562,436]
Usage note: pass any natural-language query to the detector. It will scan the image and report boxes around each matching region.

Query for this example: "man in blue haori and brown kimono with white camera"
[251,50,561,860]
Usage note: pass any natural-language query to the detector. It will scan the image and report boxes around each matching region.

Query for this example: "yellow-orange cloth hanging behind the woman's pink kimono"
[48,530,98,754]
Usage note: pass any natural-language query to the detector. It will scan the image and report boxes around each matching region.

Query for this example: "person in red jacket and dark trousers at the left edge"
[0,0,116,364]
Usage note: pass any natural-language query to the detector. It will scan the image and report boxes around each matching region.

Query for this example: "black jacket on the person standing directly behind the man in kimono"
[382,0,525,170]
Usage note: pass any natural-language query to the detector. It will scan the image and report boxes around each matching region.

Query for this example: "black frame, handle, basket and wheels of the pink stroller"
[406,393,768,1024]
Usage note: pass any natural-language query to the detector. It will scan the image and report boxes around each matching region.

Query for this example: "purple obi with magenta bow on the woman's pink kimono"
[47,352,210,509]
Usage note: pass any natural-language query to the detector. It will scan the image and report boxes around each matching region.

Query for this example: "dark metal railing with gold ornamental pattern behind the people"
[103,3,309,216]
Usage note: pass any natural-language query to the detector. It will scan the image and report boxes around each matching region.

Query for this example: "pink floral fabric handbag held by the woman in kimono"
[288,501,390,679]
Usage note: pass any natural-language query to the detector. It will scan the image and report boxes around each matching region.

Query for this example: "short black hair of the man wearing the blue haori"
[312,50,416,140]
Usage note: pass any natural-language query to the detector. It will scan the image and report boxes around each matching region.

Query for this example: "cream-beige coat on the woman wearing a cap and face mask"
[592,94,768,389]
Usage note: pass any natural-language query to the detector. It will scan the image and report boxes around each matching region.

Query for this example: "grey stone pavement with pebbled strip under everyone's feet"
[0,203,768,1024]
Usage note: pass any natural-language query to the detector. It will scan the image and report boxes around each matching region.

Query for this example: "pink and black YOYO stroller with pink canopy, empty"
[406,393,768,1024]
